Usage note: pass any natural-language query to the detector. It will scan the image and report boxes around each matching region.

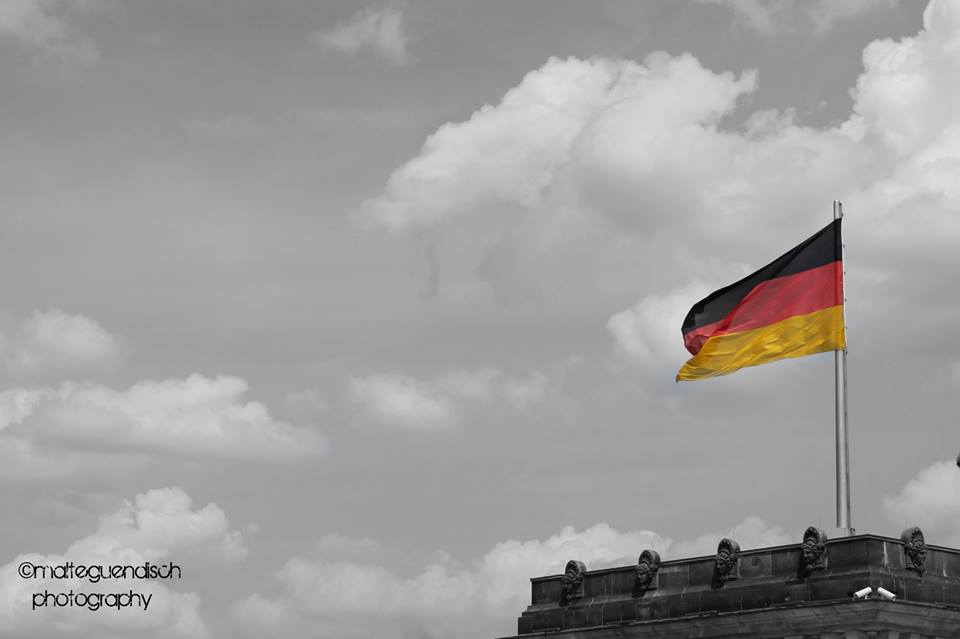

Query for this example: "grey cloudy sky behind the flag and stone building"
[0,0,960,639]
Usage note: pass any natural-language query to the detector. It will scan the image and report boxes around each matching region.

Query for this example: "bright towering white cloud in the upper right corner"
[847,0,960,290]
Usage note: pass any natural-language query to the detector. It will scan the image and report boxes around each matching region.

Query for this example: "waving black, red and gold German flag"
[677,219,847,382]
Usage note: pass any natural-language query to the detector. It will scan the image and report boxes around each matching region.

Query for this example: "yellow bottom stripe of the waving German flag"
[677,305,847,382]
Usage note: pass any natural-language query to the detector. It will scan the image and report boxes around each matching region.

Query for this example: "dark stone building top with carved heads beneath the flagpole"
[502,527,960,639]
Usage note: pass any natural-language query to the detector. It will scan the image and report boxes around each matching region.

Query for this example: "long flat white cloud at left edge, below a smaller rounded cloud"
[0,374,325,476]
